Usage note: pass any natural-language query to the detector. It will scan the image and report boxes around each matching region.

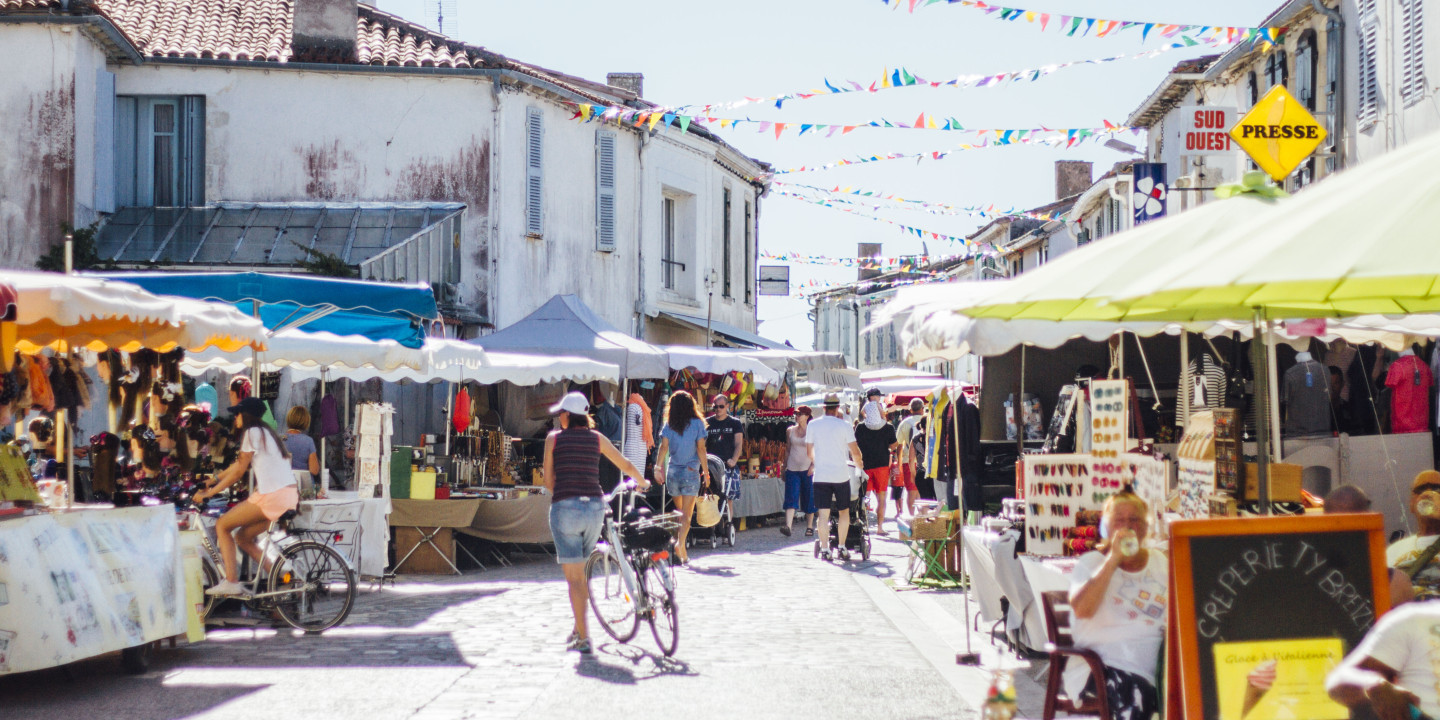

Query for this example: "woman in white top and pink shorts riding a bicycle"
[194,397,300,595]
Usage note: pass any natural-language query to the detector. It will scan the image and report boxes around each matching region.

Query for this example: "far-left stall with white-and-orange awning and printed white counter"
[0,272,265,674]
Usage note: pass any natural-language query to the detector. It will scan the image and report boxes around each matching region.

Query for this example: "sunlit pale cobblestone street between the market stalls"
[0,527,1040,720]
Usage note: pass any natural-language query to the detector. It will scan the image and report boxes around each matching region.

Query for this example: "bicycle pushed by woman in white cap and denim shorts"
[585,480,681,657]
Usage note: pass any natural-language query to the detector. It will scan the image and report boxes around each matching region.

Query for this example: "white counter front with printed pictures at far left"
[0,505,193,674]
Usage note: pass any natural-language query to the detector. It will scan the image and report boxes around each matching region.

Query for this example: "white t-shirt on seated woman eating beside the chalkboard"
[1070,549,1169,684]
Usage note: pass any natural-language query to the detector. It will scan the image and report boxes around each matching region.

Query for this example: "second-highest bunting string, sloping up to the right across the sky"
[668,37,1233,115]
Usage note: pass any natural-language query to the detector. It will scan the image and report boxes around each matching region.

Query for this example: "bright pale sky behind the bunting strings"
[377,0,1280,348]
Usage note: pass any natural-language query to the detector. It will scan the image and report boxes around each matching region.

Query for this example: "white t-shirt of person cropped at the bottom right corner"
[1346,602,1440,717]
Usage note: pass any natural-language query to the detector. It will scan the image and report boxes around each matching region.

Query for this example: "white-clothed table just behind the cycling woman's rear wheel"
[294,492,392,577]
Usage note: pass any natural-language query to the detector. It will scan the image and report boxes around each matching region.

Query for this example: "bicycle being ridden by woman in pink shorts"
[181,505,356,635]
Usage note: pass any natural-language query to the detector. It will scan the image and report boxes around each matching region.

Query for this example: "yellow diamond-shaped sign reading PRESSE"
[1230,85,1325,181]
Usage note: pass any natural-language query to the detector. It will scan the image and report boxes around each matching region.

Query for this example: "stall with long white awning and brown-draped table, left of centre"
[186,330,618,576]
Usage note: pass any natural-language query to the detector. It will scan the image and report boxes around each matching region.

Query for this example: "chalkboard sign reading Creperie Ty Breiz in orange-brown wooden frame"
[1171,514,1388,720]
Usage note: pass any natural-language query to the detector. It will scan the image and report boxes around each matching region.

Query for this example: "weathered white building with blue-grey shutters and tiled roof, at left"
[0,0,765,344]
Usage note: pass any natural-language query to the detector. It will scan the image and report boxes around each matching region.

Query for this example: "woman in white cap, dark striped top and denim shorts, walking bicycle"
[544,393,649,654]
